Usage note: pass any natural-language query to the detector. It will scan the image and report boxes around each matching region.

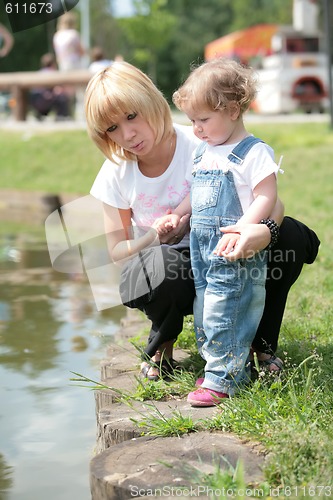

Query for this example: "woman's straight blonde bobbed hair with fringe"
[85,61,173,161]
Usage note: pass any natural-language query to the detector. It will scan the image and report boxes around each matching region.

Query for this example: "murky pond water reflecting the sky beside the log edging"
[0,231,125,500]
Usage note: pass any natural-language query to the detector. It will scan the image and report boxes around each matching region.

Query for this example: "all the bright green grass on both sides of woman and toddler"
[4,123,333,498]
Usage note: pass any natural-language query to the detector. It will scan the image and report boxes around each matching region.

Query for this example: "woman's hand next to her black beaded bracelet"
[220,224,271,261]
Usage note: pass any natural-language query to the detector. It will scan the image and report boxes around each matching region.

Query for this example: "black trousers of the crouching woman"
[120,217,320,357]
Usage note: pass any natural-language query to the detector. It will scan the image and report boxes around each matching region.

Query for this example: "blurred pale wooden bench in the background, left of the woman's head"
[0,69,92,121]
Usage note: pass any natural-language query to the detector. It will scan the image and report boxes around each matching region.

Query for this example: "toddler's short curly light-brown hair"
[172,59,257,115]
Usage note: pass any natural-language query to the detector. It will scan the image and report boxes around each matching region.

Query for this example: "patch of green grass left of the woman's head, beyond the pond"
[0,131,103,195]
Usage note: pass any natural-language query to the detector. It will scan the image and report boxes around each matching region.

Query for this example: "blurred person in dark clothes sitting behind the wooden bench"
[30,53,71,120]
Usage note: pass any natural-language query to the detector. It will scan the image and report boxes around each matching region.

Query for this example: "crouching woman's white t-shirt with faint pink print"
[90,124,200,227]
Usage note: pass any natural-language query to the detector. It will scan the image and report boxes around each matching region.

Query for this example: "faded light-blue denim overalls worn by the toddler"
[190,136,266,395]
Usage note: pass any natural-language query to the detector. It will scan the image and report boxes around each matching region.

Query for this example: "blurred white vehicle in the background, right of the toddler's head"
[253,28,329,113]
